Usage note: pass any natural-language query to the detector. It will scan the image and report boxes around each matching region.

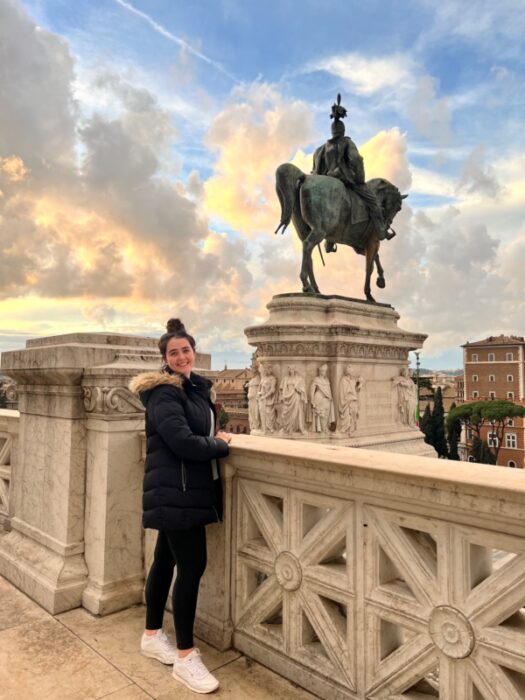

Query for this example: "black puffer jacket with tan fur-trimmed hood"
[129,372,228,530]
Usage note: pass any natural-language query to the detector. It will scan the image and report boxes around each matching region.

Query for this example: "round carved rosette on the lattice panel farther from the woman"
[428,605,476,659]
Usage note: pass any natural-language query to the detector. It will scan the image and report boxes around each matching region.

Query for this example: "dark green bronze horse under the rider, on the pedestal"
[275,163,408,302]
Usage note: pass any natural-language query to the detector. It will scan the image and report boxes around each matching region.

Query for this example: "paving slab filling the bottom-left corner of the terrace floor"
[0,618,130,700]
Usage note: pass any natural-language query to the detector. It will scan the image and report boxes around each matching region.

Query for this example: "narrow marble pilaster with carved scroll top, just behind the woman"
[82,372,149,615]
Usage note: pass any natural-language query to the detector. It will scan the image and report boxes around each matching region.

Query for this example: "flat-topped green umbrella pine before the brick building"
[447,399,525,464]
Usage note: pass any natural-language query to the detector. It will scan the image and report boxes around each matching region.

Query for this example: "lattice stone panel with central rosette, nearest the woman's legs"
[235,480,356,689]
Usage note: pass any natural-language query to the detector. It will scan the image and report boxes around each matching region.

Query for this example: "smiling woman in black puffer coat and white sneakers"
[130,319,231,693]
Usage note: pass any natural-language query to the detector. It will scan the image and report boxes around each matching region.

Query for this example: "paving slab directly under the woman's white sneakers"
[57,606,241,698]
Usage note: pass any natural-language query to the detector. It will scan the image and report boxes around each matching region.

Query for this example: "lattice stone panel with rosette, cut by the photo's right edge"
[364,507,525,700]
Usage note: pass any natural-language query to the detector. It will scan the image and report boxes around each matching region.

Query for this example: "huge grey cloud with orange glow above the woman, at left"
[0,2,251,348]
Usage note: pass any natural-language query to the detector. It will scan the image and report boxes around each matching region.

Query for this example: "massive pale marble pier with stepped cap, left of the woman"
[0,333,159,614]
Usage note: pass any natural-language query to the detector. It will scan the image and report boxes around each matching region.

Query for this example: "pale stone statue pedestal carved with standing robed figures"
[245,294,435,456]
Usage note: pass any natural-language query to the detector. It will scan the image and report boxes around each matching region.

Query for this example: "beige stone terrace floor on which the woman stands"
[0,577,316,700]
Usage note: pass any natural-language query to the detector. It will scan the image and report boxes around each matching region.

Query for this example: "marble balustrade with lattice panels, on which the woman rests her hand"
[198,436,525,700]
